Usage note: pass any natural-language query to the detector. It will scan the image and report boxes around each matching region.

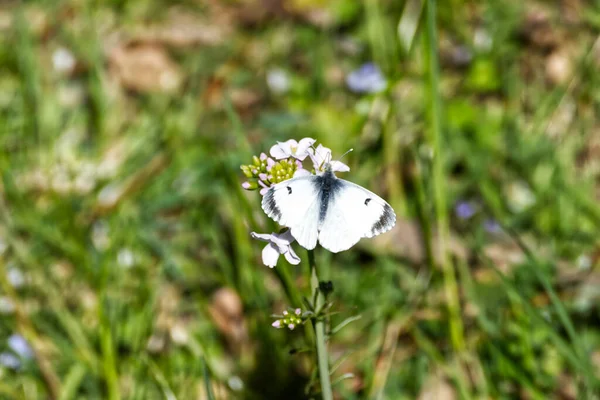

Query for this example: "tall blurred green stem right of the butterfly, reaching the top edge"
[425,0,464,350]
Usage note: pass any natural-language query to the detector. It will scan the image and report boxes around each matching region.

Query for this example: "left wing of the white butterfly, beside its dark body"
[262,176,320,250]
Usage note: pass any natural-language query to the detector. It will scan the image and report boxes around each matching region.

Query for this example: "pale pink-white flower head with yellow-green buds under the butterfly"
[240,138,350,268]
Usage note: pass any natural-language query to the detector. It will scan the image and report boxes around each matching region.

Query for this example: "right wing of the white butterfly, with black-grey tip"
[319,179,396,253]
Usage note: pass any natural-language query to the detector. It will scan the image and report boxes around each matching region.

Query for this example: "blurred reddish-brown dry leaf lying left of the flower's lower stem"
[208,288,248,350]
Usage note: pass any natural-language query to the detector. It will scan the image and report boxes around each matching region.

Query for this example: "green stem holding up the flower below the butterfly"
[308,250,333,400]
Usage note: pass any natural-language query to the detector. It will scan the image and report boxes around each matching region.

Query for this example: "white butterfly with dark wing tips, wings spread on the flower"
[262,163,396,253]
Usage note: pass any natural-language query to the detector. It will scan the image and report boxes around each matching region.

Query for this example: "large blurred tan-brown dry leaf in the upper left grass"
[108,44,183,93]
